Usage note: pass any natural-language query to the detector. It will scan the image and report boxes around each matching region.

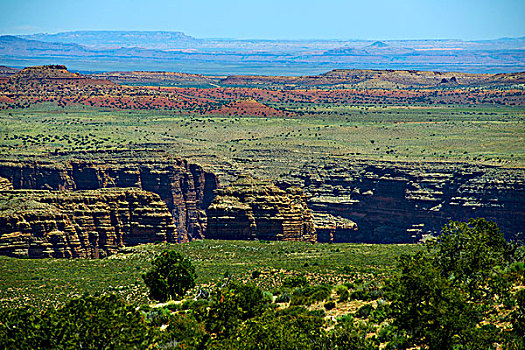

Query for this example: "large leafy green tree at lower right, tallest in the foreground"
[387,219,517,349]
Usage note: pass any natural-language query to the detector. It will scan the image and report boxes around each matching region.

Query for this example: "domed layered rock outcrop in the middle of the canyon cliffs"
[206,176,316,241]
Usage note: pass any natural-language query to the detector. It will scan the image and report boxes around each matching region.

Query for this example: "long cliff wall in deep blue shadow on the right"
[278,160,525,243]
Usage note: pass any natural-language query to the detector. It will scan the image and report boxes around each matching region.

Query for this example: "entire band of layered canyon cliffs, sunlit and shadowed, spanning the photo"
[0,150,525,257]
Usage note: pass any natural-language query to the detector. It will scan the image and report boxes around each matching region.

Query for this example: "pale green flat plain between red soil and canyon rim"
[0,105,525,178]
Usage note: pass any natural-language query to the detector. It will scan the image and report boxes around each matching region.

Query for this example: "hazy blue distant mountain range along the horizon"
[0,31,525,75]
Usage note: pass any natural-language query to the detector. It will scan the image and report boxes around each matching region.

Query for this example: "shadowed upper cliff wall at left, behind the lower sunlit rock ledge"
[0,150,218,241]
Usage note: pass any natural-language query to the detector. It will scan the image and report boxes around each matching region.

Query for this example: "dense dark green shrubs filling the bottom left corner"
[0,294,156,349]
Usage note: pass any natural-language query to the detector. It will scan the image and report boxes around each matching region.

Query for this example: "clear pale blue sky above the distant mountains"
[0,0,525,40]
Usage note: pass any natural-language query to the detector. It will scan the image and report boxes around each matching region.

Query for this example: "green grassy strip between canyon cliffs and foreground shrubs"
[0,240,422,308]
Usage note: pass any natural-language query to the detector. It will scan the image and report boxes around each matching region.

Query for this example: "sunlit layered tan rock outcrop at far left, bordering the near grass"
[0,188,178,258]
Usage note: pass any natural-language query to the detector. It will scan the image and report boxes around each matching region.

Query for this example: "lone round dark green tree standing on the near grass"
[142,250,197,302]
